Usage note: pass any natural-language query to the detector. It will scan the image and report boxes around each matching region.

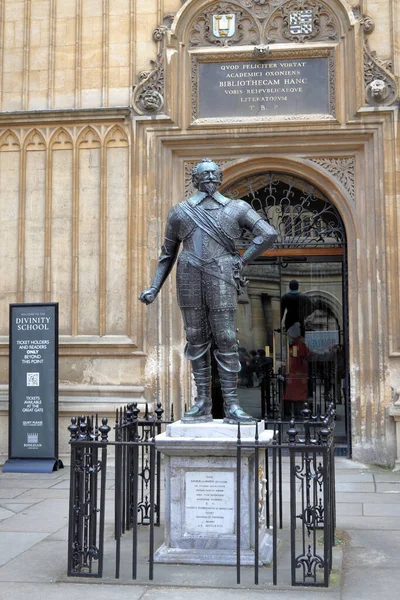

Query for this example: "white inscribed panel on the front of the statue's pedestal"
[185,471,235,535]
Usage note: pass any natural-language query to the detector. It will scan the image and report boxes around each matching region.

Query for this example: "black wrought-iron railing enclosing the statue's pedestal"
[68,404,335,586]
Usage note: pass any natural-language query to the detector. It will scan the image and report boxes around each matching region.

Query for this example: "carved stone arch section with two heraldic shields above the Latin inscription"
[188,0,339,47]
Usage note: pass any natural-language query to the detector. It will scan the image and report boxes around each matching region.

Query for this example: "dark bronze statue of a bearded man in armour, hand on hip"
[139,158,276,424]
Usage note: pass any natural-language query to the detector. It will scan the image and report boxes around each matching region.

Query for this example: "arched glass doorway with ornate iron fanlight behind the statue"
[214,171,350,453]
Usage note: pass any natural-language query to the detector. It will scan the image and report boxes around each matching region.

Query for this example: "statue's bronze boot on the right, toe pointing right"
[215,350,256,425]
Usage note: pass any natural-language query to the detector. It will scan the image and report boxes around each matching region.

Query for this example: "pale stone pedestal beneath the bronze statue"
[154,420,272,565]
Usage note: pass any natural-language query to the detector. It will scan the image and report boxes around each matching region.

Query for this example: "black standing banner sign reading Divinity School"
[3,302,63,472]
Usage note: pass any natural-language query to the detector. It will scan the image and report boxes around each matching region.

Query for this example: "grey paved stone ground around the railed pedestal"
[0,458,400,600]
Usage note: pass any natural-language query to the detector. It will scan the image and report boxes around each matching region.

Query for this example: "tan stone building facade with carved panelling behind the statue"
[0,0,400,465]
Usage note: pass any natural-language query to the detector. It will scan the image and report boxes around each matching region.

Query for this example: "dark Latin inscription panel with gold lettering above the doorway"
[197,57,329,118]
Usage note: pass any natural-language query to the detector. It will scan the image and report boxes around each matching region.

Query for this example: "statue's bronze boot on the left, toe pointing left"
[182,352,212,423]
